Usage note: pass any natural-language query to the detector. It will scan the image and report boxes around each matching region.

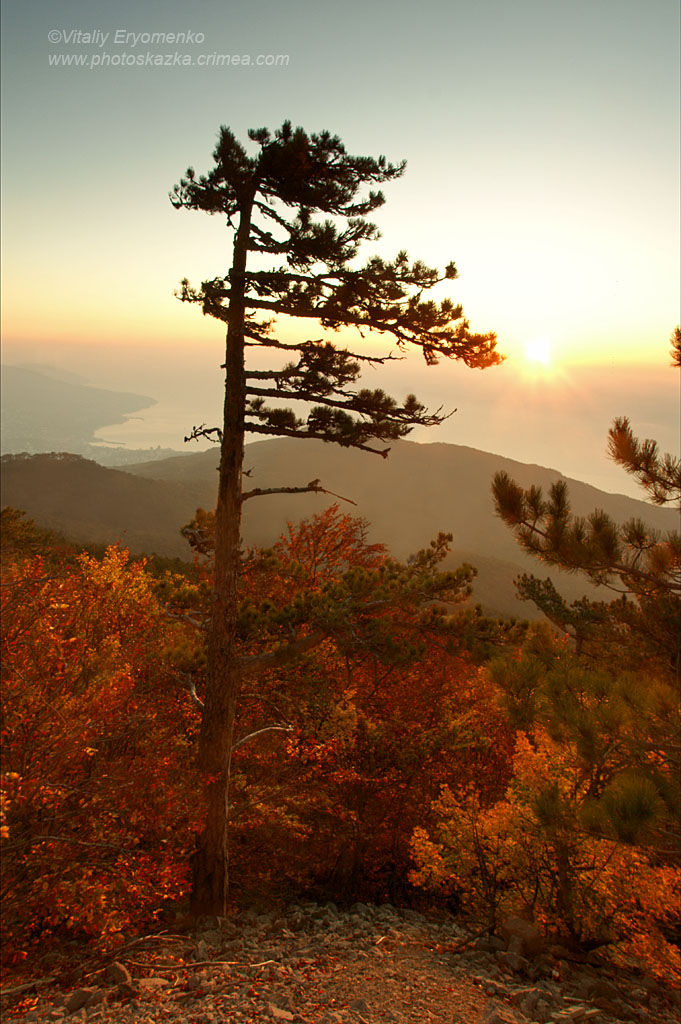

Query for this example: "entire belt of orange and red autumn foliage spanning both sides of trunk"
[1,506,681,978]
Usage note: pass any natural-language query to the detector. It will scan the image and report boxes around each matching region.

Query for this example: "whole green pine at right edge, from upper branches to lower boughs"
[493,356,681,855]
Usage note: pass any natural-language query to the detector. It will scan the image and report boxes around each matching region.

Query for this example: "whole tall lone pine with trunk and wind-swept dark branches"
[170,122,501,914]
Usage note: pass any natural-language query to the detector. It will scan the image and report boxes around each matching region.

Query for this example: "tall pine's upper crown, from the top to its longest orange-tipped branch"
[170,122,501,376]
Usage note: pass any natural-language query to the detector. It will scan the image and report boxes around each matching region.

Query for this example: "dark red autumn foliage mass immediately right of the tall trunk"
[178,506,511,900]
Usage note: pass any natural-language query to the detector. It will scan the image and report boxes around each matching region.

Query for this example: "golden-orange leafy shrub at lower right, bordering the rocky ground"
[412,729,681,981]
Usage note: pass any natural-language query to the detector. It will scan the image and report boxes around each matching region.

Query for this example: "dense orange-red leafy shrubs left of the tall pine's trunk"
[1,548,197,969]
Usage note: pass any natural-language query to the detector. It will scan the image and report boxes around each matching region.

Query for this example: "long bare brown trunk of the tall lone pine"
[191,200,252,918]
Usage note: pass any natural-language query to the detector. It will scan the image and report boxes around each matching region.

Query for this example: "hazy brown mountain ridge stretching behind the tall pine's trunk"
[2,438,677,616]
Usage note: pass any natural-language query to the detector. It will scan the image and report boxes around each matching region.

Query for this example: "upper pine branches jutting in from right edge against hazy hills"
[492,342,681,663]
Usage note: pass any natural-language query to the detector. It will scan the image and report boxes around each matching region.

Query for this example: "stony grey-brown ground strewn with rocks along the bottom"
[2,903,681,1024]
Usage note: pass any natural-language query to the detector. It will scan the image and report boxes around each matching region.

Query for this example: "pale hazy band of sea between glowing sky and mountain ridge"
[3,344,679,498]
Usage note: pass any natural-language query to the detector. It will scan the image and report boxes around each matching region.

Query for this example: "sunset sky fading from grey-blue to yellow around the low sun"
[3,0,680,489]
